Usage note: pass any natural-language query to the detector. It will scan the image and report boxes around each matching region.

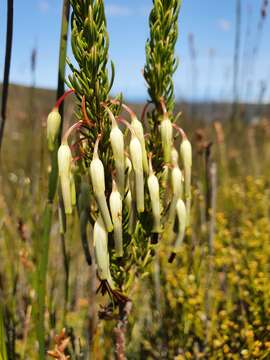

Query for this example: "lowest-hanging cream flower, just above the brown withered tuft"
[93,215,110,280]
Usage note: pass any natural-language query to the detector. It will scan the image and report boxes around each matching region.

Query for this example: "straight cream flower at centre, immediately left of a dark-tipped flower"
[130,134,144,213]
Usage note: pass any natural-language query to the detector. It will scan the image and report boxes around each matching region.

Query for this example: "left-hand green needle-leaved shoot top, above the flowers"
[67,0,114,136]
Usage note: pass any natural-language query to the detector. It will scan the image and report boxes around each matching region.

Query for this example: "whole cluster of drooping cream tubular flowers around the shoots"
[48,94,192,296]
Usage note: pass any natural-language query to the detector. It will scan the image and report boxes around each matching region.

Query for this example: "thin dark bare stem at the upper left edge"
[0,0,13,150]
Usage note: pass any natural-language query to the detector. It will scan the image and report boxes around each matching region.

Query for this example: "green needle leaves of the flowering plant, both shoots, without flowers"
[63,1,186,306]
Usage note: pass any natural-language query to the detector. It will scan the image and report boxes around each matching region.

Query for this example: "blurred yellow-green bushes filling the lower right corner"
[127,177,270,360]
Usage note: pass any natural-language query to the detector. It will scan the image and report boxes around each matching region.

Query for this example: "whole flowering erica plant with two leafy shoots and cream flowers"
[45,0,192,358]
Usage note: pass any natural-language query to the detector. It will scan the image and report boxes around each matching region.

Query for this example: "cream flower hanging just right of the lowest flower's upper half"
[110,181,123,257]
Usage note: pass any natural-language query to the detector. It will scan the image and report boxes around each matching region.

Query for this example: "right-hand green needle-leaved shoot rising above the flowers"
[144,0,181,113]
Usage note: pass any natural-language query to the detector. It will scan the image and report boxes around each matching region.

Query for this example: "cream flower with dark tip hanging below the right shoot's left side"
[147,159,161,233]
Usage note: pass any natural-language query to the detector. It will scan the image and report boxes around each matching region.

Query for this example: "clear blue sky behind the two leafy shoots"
[0,0,270,101]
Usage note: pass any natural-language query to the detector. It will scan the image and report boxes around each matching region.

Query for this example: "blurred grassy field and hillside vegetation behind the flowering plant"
[0,1,270,360]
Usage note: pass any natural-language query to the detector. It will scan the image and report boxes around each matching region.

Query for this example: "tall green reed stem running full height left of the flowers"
[36,0,70,360]
